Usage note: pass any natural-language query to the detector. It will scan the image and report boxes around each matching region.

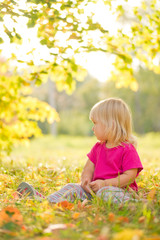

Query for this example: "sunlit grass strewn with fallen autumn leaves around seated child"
[0,133,160,240]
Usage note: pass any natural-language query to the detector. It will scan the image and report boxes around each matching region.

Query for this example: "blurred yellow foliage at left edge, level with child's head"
[0,59,58,157]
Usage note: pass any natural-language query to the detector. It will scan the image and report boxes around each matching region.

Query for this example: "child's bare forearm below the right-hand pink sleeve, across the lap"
[89,168,138,192]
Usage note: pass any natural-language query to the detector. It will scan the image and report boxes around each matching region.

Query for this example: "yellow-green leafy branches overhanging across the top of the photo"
[0,0,160,88]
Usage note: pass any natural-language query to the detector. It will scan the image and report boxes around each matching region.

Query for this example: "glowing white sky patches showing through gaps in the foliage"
[0,0,140,81]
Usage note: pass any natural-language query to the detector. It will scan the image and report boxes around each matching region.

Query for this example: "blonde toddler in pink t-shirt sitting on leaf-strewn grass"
[17,98,143,203]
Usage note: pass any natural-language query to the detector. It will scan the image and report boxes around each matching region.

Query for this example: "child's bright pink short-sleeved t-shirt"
[87,142,143,191]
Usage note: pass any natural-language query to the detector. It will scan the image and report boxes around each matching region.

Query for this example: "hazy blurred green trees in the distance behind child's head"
[33,68,160,135]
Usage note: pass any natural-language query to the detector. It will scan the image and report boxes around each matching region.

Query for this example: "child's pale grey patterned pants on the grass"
[48,183,136,203]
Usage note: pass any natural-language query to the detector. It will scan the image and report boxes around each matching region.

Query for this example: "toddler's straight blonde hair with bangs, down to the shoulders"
[89,98,137,147]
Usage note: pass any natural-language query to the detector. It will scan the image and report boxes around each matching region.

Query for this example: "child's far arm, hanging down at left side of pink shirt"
[81,159,95,192]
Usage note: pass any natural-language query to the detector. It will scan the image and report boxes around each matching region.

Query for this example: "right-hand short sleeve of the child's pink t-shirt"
[122,148,143,176]
